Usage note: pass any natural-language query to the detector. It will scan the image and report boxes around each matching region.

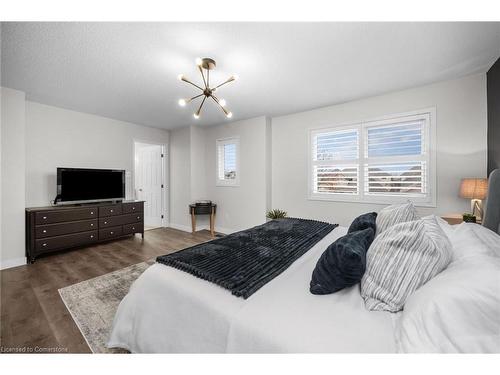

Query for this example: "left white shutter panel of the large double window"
[311,129,359,195]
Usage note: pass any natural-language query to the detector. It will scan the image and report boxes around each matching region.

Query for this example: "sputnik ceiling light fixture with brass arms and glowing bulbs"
[178,57,238,119]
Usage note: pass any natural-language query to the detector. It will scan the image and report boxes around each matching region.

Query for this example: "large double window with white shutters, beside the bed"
[309,110,435,205]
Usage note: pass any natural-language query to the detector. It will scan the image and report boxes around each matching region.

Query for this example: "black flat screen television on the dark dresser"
[57,168,125,204]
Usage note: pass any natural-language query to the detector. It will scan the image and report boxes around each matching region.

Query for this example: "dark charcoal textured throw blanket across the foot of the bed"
[156,218,338,299]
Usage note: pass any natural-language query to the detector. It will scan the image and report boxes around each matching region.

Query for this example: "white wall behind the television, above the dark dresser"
[26,101,169,206]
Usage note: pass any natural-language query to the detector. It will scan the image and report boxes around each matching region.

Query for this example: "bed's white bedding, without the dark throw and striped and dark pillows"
[108,172,500,353]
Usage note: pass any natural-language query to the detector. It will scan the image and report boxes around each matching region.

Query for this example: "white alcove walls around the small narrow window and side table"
[170,117,270,233]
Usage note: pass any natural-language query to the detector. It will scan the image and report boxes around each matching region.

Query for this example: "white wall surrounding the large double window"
[272,74,487,225]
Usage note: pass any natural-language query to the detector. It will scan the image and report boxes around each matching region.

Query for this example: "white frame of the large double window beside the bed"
[307,107,437,207]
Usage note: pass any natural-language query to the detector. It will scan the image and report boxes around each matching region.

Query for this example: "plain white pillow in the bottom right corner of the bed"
[395,255,500,353]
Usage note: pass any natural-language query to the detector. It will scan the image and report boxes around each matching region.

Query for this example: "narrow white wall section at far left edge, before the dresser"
[0,87,26,269]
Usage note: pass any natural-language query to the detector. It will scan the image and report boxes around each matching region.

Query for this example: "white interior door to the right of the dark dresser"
[135,143,163,228]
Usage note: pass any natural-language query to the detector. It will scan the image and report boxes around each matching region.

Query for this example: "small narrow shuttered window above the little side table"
[217,138,239,186]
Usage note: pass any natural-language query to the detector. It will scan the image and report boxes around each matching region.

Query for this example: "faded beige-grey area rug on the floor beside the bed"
[59,259,154,353]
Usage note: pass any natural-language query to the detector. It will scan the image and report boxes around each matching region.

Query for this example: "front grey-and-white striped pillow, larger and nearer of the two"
[361,216,452,312]
